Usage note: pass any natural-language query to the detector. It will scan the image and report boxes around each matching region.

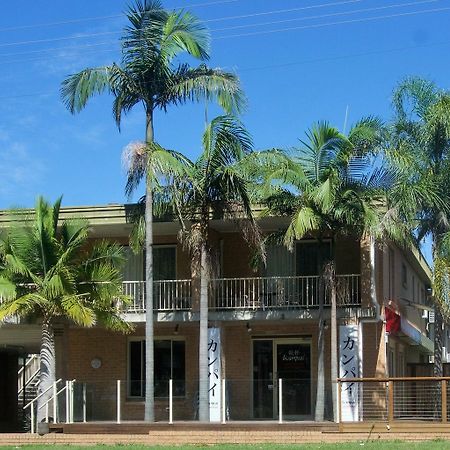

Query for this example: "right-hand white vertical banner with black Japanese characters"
[339,325,360,422]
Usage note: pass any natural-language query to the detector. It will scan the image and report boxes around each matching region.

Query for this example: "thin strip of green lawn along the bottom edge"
[0,440,450,450]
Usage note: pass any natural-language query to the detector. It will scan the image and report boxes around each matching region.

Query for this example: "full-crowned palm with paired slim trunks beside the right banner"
[266,118,387,421]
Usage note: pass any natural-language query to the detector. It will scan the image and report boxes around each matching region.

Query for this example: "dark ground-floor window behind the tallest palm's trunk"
[128,339,186,397]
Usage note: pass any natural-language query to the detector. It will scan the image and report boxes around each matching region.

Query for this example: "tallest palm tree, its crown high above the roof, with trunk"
[61,0,244,421]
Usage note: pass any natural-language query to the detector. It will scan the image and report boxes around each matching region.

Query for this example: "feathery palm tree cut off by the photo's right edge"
[386,78,450,376]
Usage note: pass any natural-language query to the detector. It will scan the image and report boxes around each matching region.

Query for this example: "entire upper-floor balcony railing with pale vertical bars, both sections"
[123,274,361,313]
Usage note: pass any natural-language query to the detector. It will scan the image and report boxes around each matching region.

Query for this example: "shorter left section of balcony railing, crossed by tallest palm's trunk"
[123,280,192,313]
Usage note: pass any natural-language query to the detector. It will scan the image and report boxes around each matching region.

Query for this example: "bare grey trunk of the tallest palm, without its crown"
[144,108,155,422]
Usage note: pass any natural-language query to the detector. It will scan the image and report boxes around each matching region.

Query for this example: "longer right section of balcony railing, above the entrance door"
[210,274,361,310]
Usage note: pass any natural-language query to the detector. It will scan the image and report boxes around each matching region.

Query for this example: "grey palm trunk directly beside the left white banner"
[198,242,209,422]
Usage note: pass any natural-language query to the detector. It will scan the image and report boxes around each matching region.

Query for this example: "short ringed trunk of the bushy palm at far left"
[37,318,56,423]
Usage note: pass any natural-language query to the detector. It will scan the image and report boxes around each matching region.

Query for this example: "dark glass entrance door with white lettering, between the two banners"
[253,339,311,420]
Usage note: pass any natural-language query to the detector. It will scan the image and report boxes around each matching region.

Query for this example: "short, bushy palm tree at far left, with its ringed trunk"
[0,197,130,420]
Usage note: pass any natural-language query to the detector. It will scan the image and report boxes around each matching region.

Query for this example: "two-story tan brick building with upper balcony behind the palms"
[0,205,433,428]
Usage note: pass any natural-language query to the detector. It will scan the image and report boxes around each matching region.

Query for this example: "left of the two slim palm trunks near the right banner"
[315,270,325,422]
